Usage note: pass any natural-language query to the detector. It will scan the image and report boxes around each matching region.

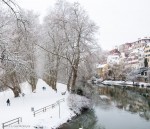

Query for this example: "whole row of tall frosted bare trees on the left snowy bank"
[0,0,99,97]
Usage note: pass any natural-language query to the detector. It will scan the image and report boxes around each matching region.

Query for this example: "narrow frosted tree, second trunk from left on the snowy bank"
[16,11,39,91]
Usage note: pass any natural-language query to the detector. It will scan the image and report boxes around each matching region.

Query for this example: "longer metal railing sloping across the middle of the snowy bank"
[33,98,65,117]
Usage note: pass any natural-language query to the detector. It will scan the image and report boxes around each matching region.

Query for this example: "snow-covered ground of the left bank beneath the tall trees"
[0,79,89,129]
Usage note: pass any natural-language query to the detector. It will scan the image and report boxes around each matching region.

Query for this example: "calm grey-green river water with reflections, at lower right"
[62,87,150,129]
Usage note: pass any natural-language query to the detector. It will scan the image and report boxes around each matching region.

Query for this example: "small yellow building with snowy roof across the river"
[97,64,108,79]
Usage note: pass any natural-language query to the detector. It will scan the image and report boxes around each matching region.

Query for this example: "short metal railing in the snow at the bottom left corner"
[2,117,22,129]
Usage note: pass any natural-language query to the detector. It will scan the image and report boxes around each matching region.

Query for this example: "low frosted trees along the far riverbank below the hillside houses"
[106,61,149,85]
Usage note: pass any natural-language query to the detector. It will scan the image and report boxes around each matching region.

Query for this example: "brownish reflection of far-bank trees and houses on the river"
[98,86,150,120]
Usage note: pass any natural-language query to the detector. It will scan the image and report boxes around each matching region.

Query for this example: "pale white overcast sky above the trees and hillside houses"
[16,0,150,50]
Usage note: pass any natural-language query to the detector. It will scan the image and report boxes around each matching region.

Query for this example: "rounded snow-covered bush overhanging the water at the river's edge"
[68,94,92,114]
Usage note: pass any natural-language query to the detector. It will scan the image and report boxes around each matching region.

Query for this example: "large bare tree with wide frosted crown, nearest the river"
[42,1,97,90]
